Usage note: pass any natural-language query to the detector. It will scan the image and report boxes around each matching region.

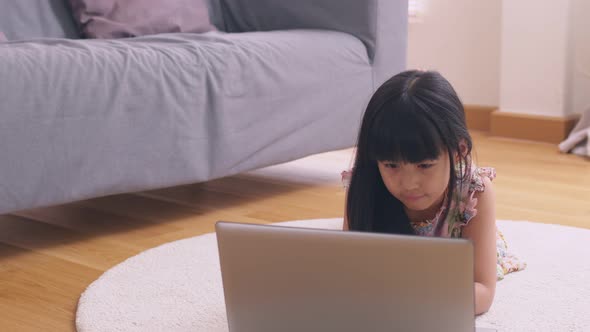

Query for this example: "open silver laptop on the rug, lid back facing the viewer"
[216,222,493,332]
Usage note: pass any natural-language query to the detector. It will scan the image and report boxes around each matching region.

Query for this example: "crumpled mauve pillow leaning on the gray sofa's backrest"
[70,0,215,38]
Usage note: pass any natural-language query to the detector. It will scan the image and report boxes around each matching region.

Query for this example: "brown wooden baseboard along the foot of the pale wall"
[465,105,580,144]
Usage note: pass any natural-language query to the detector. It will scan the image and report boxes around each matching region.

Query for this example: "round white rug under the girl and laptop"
[76,219,590,332]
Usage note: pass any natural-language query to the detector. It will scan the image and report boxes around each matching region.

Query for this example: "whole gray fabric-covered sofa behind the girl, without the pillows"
[0,0,407,214]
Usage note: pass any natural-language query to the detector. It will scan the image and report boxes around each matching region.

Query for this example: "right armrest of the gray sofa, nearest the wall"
[218,0,408,86]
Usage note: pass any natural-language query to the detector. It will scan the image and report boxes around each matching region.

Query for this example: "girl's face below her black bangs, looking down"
[378,152,451,212]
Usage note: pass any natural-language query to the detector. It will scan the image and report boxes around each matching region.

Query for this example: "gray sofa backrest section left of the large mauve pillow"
[0,0,80,40]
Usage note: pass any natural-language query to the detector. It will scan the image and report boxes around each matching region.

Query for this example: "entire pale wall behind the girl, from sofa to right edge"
[408,0,590,116]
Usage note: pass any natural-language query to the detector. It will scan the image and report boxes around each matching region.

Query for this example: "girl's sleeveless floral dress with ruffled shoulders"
[341,165,526,280]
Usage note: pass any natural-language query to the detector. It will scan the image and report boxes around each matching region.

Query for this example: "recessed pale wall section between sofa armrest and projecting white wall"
[408,0,504,106]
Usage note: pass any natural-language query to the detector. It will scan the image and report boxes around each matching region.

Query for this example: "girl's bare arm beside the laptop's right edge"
[463,177,497,315]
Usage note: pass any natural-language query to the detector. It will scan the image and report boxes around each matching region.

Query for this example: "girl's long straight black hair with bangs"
[346,70,472,234]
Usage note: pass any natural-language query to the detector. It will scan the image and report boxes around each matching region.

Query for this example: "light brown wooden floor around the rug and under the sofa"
[0,133,590,331]
